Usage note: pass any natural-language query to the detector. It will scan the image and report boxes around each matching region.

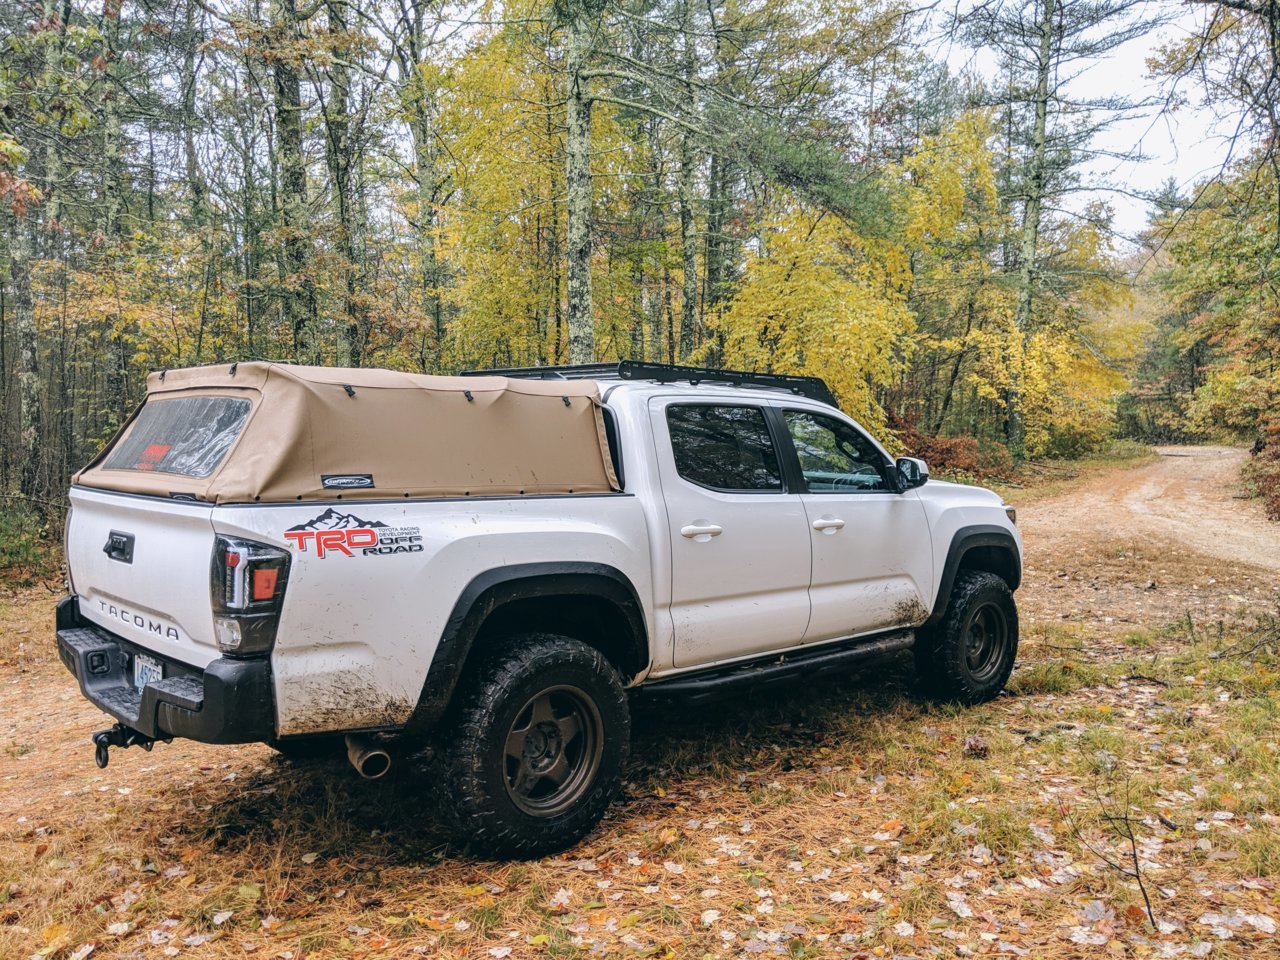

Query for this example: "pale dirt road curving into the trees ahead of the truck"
[1019,447,1280,640]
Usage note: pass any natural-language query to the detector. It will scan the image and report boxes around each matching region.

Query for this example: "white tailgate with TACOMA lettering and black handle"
[67,486,219,668]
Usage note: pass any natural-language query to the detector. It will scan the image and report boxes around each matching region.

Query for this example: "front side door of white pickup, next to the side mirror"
[782,407,933,643]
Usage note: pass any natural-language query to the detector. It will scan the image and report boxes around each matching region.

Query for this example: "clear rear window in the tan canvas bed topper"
[102,397,251,479]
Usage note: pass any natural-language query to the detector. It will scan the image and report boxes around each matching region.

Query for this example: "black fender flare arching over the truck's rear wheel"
[403,561,650,733]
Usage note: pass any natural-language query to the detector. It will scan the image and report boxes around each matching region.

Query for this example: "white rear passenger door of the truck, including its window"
[649,397,810,667]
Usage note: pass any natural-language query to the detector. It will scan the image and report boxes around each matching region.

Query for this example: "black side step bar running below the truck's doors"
[635,630,915,703]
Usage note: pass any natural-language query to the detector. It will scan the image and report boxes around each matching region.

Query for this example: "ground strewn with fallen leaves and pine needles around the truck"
[0,453,1280,960]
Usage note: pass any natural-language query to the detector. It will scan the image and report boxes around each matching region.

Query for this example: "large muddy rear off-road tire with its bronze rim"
[436,634,631,858]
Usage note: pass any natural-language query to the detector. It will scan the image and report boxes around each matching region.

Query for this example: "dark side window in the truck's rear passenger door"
[667,404,782,493]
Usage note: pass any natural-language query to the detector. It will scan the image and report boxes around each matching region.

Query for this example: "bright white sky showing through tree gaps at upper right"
[947,4,1230,251]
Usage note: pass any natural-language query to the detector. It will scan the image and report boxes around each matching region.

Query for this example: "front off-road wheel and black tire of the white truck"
[915,571,1018,705]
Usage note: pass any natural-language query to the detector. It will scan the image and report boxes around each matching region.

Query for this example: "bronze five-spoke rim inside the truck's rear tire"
[503,685,604,817]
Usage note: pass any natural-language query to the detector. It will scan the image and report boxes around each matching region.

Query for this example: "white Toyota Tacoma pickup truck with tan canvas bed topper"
[56,362,1021,856]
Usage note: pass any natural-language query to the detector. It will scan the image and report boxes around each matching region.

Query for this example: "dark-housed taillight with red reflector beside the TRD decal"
[210,536,289,657]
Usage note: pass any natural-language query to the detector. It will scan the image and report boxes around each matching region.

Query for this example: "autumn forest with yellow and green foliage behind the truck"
[0,0,1280,522]
